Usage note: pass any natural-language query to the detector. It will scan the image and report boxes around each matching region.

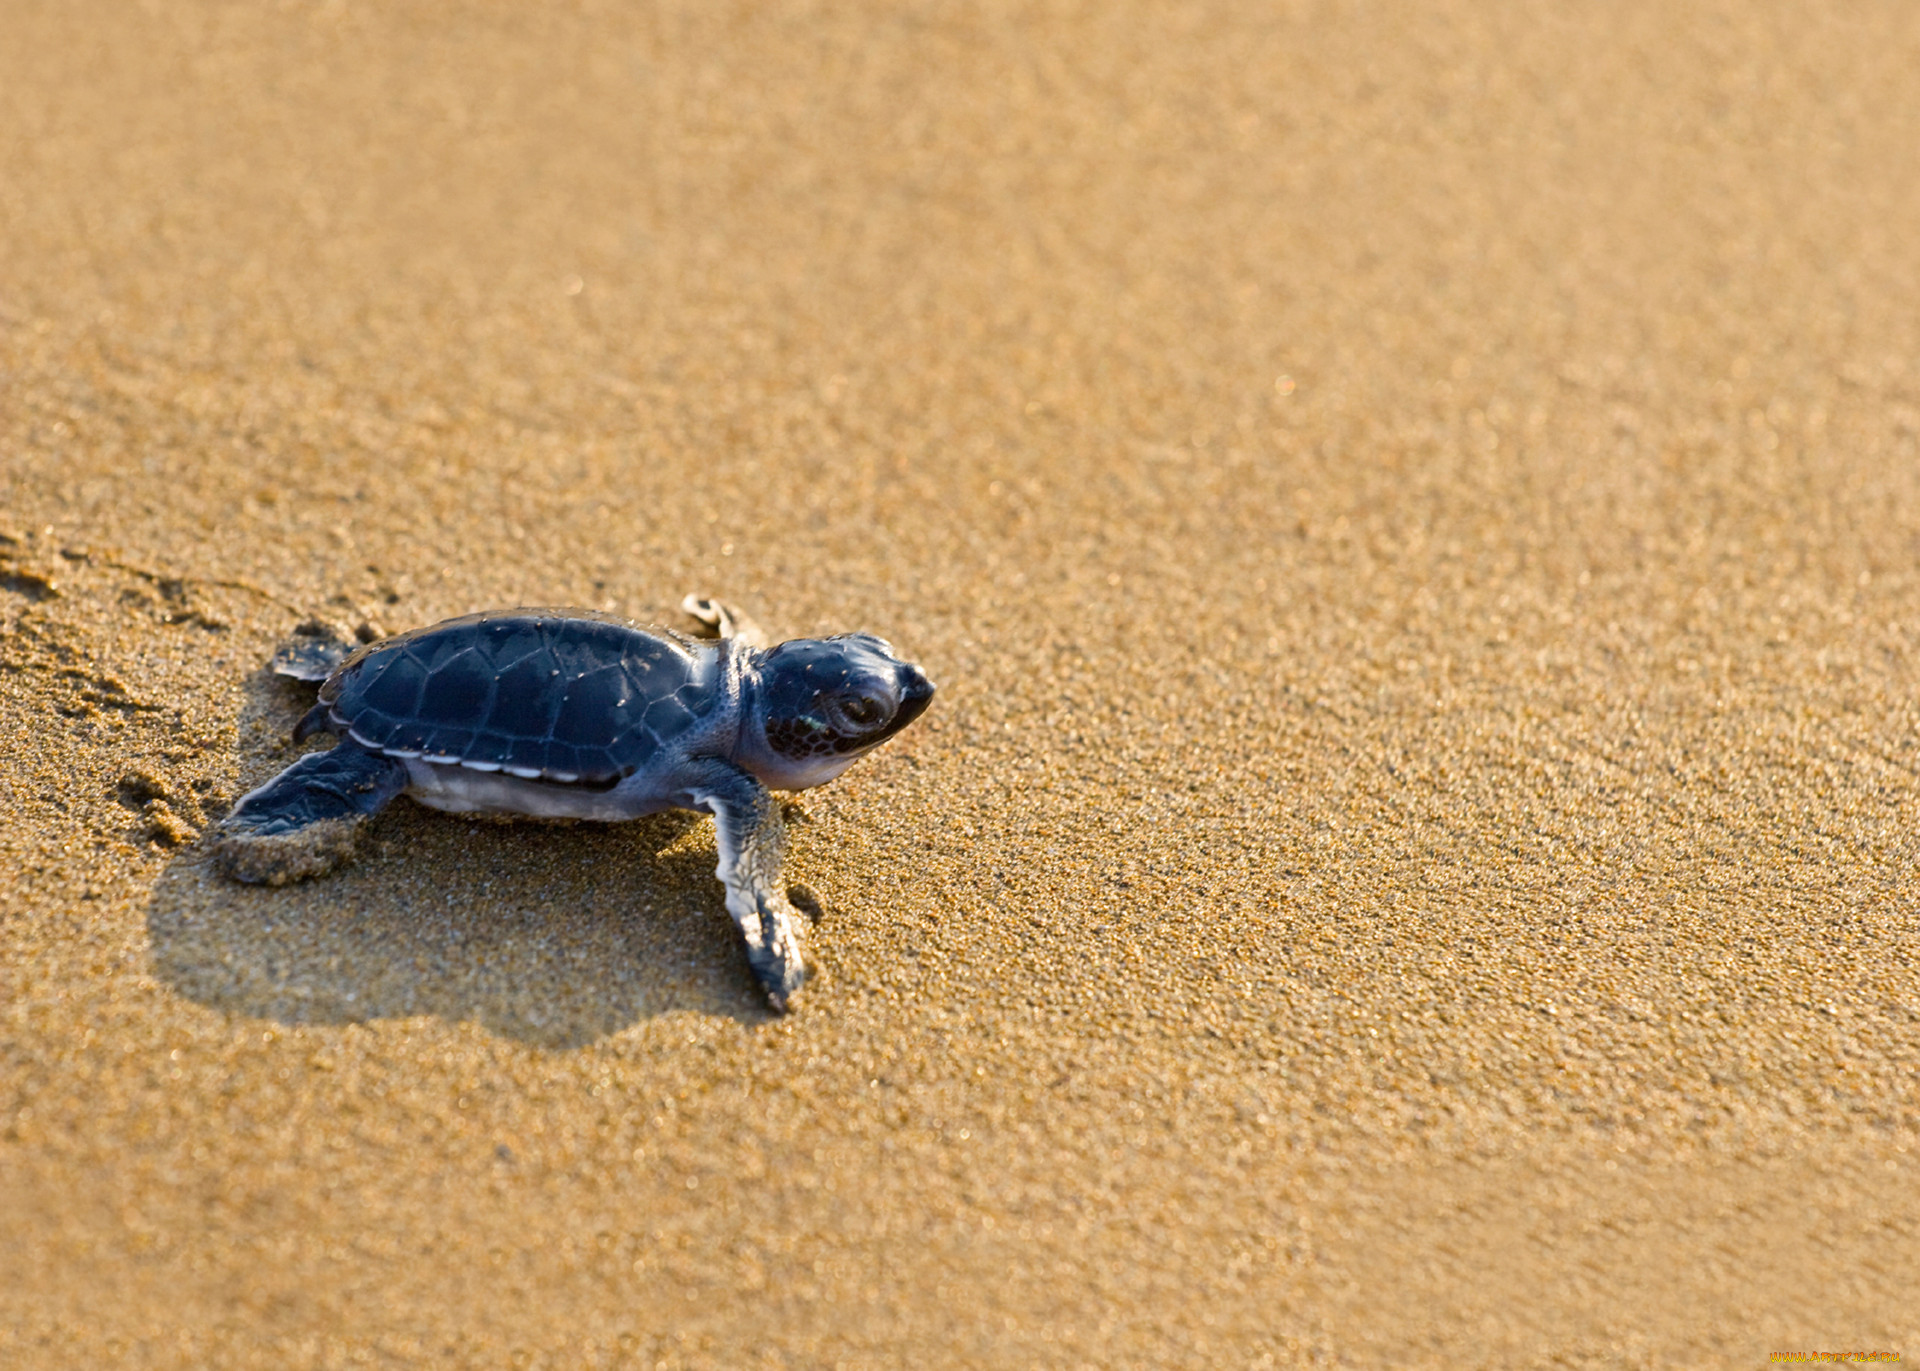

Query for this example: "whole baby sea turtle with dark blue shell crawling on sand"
[213,595,933,1008]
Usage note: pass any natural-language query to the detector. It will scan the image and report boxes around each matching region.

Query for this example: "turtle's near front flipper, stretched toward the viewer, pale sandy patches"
[682,758,806,1010]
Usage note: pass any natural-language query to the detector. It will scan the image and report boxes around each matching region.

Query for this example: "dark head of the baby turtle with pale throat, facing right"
[733,634,933,791]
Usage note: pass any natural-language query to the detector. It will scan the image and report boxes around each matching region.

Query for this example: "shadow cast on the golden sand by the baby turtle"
[148,672,772,1048]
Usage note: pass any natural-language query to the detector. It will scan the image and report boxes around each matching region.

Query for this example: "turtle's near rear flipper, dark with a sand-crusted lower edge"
[213,743,407,885]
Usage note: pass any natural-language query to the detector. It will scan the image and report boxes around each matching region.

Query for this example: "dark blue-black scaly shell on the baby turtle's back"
[321,609,714,787]
